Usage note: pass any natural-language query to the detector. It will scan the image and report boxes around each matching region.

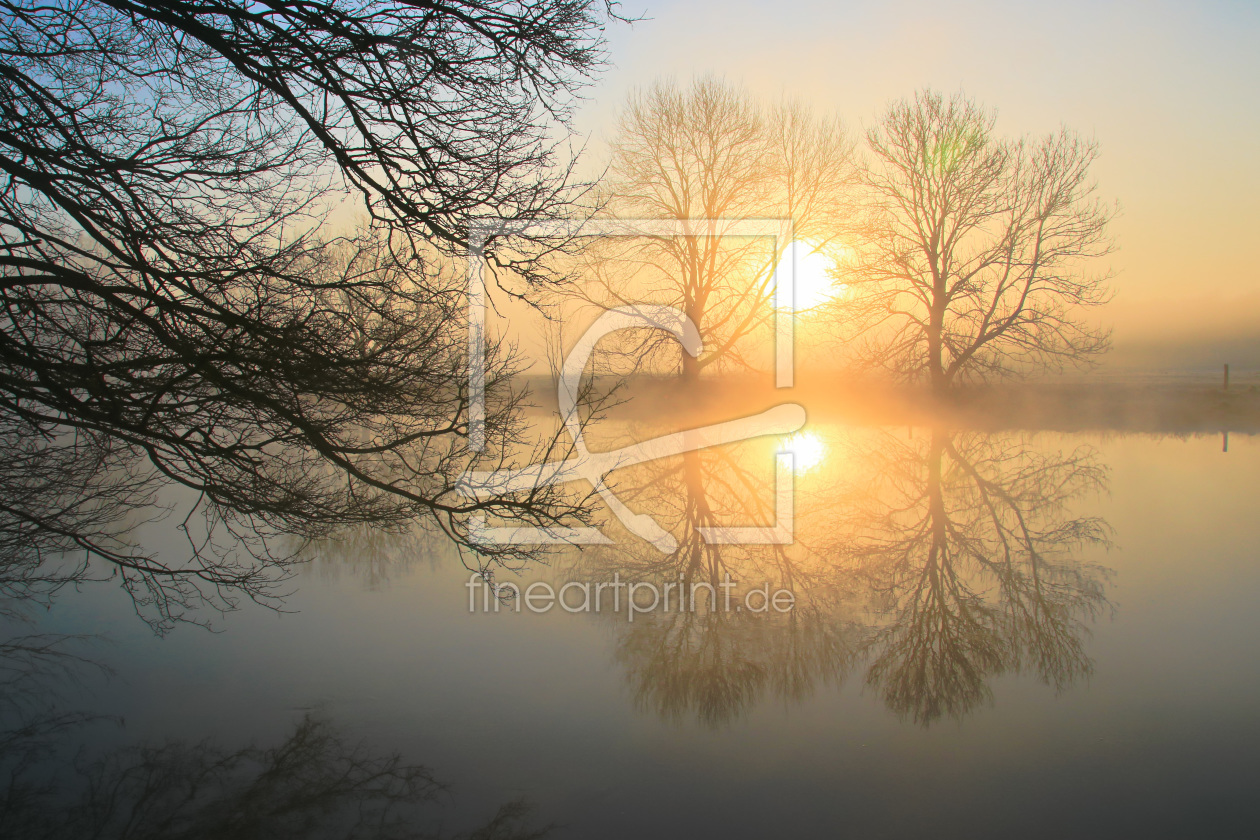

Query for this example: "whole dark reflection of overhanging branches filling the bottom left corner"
[0,633,549,840]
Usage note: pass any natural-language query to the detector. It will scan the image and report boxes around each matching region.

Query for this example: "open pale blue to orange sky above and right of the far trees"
[575,0,1260,370]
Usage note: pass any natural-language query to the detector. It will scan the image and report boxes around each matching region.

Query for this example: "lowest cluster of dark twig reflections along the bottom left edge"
[0,717,547,840]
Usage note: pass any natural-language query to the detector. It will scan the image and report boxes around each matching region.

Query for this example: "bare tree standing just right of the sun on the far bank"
[835,91,1113,392]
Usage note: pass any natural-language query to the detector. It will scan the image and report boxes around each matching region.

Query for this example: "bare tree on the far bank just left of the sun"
[582,78,853,378]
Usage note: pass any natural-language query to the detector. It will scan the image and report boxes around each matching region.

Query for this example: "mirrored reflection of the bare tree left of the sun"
[578,450,854,725]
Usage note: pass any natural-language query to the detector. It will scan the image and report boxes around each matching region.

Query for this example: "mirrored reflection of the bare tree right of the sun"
[847,429,1108,723]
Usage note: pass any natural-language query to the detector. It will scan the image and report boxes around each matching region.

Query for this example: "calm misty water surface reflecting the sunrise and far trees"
[9,428,1260,837]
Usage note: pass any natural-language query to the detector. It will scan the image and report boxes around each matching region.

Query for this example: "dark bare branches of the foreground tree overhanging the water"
[0,0,619,621]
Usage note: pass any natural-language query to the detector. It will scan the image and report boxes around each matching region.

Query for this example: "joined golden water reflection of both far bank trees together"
[561,428,1109,725]
